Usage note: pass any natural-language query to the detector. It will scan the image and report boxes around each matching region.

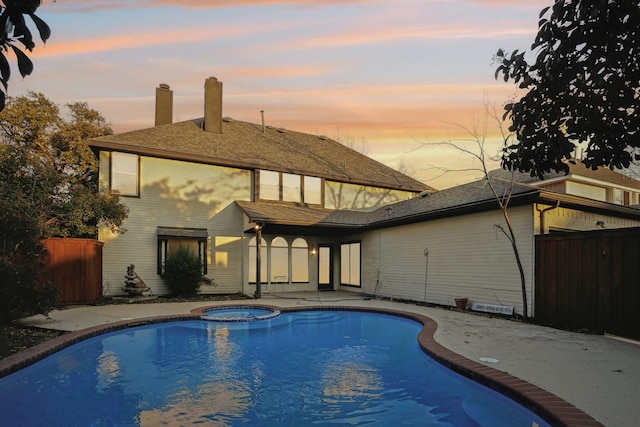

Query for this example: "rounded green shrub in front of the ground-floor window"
[162,246,208,295]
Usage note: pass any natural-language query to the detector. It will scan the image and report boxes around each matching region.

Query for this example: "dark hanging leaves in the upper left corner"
[0,0,51,111]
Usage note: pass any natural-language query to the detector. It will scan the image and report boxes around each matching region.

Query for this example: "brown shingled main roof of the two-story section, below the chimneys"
[89,119,433,192]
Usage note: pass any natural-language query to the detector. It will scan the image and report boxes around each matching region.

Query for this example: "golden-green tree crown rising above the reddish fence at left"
[0,93,128,238]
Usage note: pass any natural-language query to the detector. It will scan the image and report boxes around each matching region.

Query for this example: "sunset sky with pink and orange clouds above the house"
[9,0,553,189]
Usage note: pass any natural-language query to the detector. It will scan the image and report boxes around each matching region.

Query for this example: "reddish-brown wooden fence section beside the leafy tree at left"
[43,238,104,304]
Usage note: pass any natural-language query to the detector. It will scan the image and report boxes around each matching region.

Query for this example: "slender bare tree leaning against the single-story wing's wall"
[418,108,529,319]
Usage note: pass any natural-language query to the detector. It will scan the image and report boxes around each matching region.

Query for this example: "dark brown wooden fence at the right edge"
[534,228,640,339]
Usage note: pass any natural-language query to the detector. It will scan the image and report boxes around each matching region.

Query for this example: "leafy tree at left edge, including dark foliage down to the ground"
[0,93,127,321]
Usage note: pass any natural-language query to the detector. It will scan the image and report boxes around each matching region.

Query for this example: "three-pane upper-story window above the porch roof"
[257,170,323,205]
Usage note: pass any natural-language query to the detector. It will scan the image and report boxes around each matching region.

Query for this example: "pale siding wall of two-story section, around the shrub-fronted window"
[99,156,251,295]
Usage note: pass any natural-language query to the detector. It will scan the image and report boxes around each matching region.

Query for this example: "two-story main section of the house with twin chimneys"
[90,77,433,295]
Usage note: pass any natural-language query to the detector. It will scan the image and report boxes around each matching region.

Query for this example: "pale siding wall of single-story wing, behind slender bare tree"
[363,206,534,314]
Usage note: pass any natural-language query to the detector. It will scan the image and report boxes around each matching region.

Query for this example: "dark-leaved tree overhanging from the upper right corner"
[496,0,640,177]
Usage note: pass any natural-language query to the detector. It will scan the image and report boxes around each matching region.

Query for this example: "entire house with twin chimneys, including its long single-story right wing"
[90,78,640,320]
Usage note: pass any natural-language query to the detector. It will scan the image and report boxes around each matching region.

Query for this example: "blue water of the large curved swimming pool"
[0,311,548,427]
